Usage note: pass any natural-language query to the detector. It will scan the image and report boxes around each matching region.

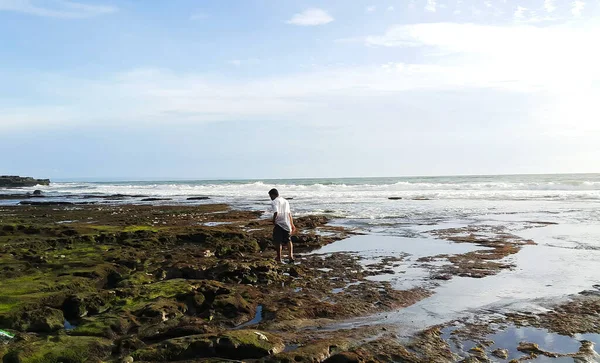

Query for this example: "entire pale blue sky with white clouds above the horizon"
[0,0,600,179]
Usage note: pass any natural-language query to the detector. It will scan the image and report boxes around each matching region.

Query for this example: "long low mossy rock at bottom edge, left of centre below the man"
[133,330,285,361]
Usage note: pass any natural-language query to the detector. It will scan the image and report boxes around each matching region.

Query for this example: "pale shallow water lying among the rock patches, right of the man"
[318,222,600,336]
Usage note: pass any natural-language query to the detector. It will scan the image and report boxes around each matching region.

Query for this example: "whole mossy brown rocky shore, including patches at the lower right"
[0,204,600,363]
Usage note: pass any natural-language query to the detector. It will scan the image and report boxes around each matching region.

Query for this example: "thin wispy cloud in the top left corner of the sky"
[0,0,118,19]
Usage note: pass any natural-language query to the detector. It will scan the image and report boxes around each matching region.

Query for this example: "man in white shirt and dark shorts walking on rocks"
[269,189,296,262]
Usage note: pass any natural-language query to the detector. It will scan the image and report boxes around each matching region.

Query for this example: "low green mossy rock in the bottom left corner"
[3,336,111,363]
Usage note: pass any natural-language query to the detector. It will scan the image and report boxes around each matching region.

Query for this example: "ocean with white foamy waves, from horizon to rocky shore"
[0,174,600,230]
